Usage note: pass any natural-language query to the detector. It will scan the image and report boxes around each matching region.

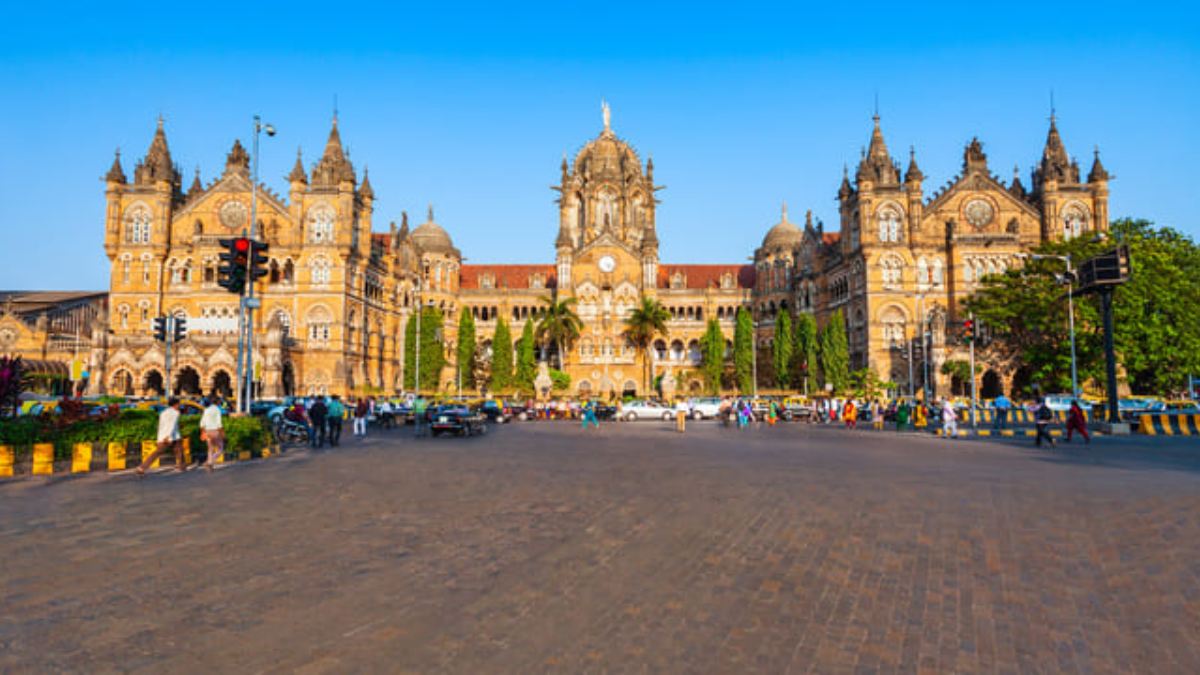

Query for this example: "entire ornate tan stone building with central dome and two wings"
[70,107,1108,396]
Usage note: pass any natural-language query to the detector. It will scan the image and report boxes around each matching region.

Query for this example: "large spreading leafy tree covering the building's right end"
[966,219,1200,394]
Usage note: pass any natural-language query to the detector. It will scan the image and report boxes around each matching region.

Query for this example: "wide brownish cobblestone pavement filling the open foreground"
[0,423,1200,674]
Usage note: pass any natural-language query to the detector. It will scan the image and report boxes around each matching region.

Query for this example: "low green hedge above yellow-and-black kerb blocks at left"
[0,410,271,459]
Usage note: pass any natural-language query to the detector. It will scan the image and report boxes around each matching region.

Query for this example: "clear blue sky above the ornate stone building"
[0,2,1200,288]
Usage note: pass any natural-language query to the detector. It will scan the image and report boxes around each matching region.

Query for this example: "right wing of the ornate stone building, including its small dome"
[755,115,1109,396]
